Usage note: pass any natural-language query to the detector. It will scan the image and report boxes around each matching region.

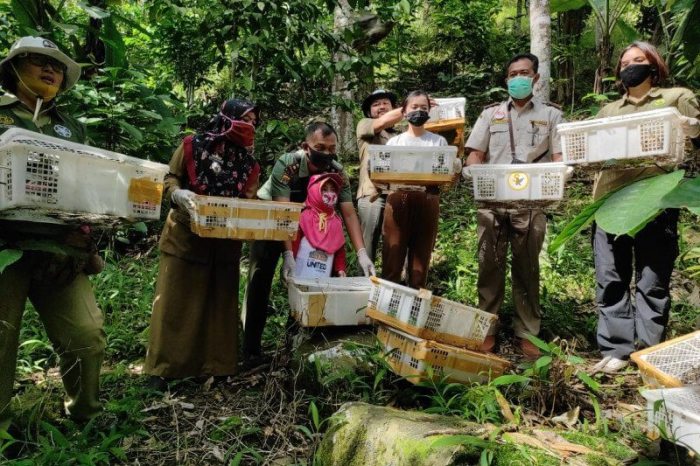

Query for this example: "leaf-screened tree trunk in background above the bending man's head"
[331,1,355,157]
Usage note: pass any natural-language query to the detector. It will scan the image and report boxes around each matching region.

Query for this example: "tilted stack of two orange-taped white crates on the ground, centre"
[367,277,509,383]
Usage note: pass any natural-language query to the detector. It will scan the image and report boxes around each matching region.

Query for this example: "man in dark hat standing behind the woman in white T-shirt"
[356,89,403,260]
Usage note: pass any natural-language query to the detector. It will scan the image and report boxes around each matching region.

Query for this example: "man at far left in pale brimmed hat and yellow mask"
[0,37,105,430]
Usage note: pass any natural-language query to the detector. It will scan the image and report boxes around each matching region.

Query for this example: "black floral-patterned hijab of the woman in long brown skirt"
[185,99,259,197]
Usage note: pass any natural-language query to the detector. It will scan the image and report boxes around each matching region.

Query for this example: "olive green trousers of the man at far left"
[0,252,105,422]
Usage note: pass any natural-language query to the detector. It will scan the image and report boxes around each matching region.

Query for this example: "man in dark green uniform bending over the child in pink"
[243,122,375,366]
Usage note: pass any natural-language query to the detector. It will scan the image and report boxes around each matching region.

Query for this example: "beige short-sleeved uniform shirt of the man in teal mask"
[465,99,564,164]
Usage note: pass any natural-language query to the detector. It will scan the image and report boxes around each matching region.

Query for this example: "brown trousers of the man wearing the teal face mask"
[476,209,547,338]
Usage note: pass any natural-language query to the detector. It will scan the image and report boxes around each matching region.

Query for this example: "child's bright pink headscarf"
[299,173,345,254]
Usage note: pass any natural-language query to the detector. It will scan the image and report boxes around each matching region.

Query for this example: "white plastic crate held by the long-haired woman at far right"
[557,107,685,164]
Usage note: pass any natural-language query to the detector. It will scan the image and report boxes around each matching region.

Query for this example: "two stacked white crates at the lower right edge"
[632,331,700,454]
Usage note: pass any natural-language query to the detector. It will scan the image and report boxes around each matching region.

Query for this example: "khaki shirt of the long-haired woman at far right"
[593,87,700,200]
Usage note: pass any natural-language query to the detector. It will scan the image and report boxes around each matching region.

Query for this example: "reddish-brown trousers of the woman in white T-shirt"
[382,191,440,288]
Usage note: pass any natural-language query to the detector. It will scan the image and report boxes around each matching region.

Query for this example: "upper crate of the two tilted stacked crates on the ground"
[367,277,497,350]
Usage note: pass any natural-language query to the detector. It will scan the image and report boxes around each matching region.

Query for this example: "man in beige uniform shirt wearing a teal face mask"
[465,53,564,358]
